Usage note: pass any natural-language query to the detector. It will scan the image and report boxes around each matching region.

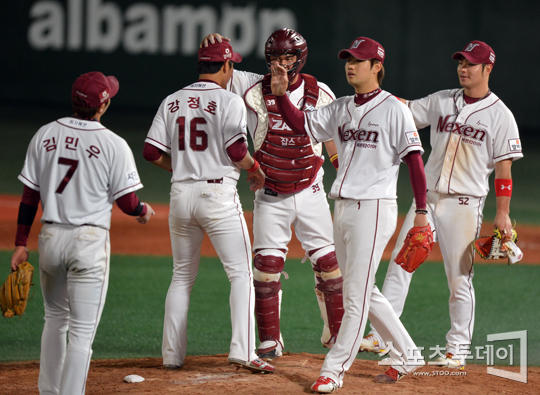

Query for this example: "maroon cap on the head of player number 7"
[71,71,120,107]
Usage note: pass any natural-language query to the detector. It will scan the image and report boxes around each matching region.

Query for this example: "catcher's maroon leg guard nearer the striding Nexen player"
[310,246,345,348]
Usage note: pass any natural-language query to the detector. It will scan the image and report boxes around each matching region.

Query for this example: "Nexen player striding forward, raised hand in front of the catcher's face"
[272,37,427,393]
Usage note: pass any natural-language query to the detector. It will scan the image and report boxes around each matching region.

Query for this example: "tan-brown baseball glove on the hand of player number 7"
[0,262,34,318]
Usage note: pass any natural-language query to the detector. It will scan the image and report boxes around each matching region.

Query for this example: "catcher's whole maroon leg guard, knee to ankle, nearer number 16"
[253,250,285,360]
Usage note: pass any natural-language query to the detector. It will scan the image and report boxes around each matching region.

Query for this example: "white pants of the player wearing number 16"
[162,177,257,366]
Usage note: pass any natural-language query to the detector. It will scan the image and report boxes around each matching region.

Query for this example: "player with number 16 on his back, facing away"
[144,42,275,373]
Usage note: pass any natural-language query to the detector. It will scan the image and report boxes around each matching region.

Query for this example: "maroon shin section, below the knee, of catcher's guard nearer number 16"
[253,280,281,353]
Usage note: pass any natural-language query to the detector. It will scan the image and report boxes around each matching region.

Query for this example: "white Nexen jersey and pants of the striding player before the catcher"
[305,91,423,383]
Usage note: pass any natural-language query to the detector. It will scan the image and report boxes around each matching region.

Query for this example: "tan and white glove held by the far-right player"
[472,228,523,263]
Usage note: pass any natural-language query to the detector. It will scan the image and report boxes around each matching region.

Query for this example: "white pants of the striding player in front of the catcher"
[320,199,423,383]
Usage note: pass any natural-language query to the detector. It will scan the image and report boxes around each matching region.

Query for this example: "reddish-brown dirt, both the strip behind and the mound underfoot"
[0,195,540,395]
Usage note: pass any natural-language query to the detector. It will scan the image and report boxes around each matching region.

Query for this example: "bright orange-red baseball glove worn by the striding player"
[395,224,433,273]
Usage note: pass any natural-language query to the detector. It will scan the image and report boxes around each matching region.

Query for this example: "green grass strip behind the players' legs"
[0,251,540,366]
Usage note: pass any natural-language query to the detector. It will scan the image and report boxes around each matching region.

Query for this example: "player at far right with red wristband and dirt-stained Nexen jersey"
[362,41,523,368]
